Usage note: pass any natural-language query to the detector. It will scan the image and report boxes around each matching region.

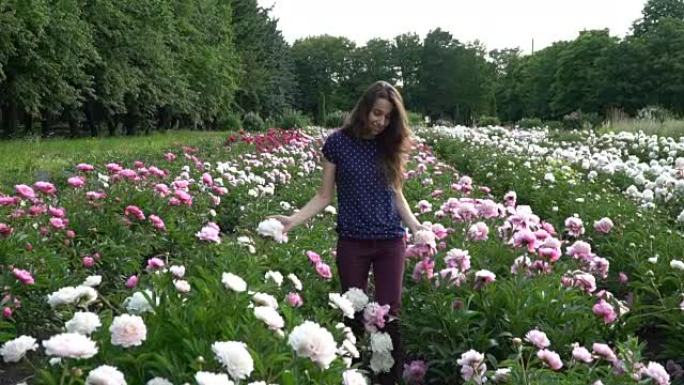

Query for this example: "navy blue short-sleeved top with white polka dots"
[322,130,404,239]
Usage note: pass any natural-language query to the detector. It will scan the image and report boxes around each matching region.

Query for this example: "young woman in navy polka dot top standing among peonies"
[273,81,422,384]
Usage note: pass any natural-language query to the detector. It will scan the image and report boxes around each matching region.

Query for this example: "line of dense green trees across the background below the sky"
[0,0,684,137]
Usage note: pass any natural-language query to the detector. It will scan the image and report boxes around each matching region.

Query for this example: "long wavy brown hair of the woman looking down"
[342,80,411,189]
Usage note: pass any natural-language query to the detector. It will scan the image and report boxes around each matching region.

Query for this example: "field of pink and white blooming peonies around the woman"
[0,127,684,385]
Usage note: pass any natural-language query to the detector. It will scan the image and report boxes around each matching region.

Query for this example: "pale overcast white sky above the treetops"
[258,0,646,53]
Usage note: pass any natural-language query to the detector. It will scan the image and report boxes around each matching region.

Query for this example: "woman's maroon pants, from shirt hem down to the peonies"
[336,238,406,317]
